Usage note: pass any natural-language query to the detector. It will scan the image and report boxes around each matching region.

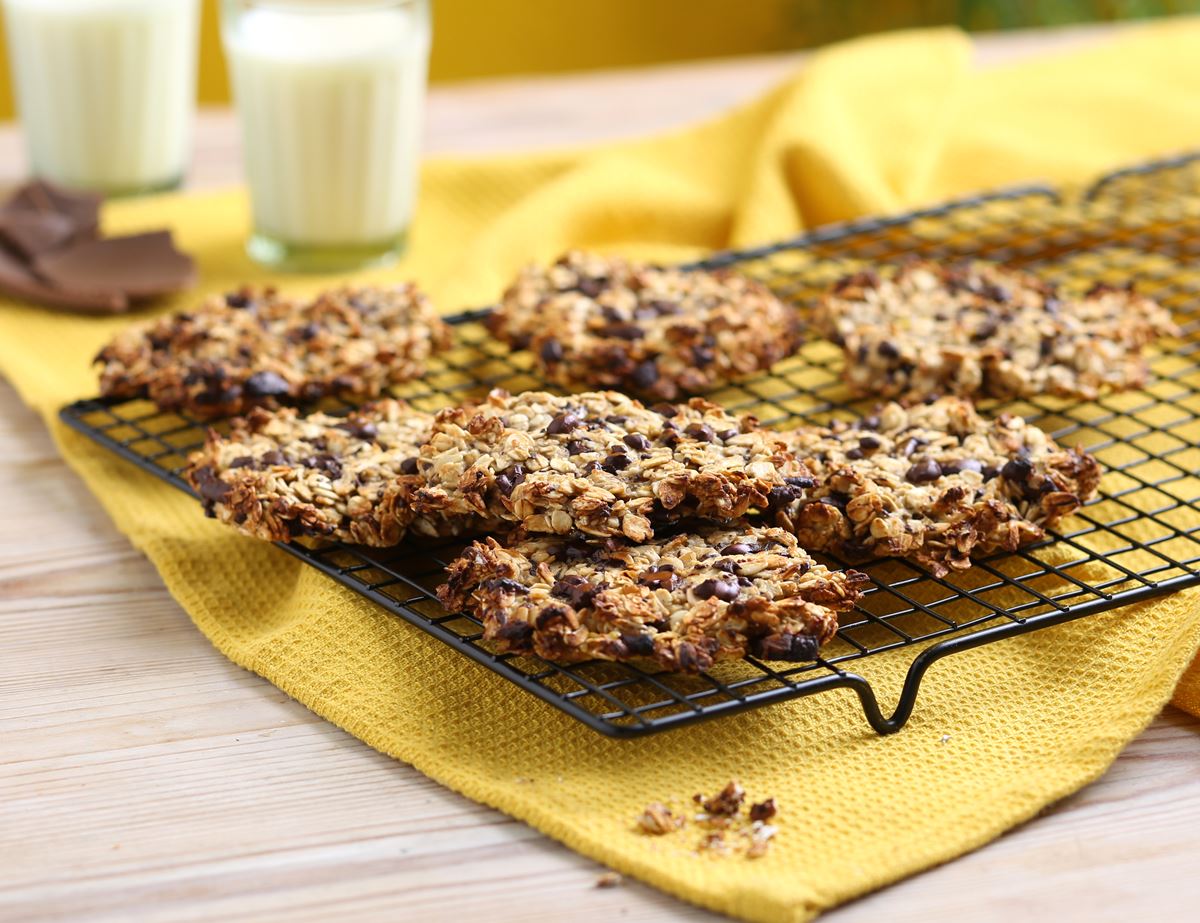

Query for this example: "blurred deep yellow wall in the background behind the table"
[0,0,1180,119]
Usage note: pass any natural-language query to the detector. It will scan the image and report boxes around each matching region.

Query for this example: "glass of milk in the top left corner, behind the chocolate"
[4,0,199,194]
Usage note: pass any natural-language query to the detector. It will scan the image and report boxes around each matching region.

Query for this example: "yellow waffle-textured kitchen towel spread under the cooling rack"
[0,22,1200,921]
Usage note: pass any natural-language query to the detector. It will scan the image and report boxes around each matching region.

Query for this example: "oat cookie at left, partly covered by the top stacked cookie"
[186,400,474,546]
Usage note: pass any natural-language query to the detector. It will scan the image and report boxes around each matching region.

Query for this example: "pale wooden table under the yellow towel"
[0,23,1200,923]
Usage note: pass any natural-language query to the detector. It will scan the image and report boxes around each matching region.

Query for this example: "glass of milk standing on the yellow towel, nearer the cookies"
[221,0,431,271]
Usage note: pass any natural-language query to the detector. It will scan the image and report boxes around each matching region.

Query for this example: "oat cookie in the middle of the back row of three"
[488,251,799,401]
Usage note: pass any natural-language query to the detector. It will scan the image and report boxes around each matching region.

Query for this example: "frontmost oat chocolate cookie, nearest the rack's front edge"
[438,526,866,672]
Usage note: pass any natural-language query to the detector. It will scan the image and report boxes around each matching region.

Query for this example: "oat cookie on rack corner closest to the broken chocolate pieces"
[96,284,450,419]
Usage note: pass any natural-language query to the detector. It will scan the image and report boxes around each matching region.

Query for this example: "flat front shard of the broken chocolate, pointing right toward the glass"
[34,230,196,301]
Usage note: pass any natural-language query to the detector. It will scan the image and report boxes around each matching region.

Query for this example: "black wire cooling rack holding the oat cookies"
[61,155,1200,737]
